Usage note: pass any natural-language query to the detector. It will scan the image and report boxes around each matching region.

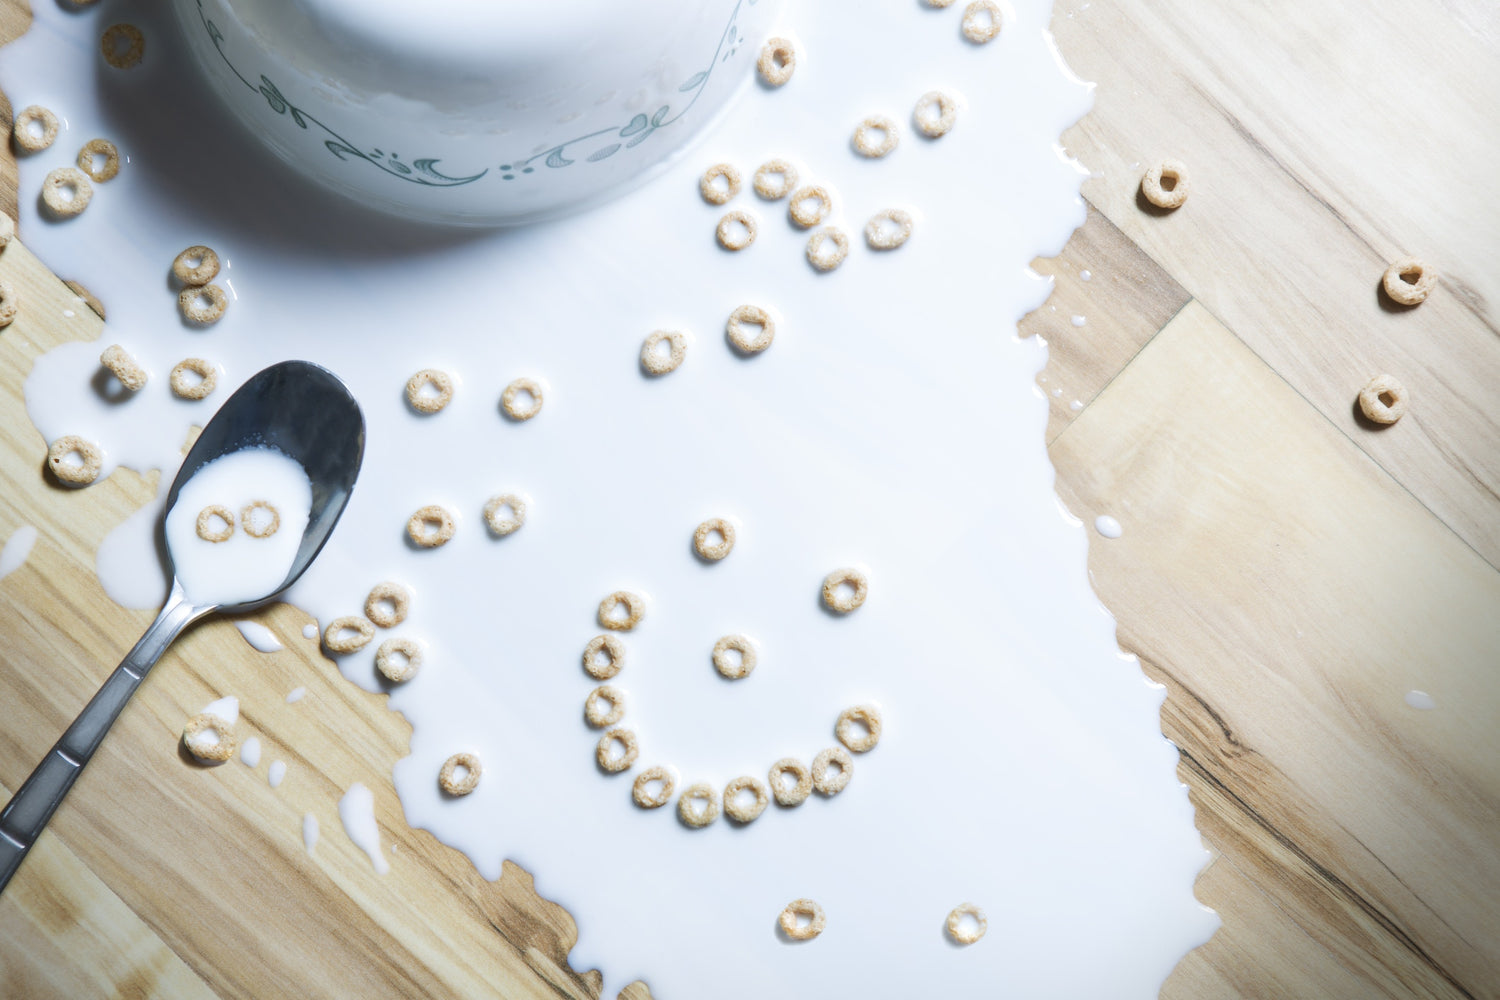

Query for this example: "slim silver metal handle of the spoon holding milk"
[0,583,209,892]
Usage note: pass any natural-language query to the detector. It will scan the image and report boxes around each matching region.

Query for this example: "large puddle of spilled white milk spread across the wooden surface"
[0,0,1217,1000]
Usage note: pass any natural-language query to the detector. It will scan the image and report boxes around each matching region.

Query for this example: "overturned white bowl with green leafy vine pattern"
[176,0,782,225]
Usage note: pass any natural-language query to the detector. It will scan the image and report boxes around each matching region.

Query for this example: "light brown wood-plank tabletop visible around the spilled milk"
[0,0,1500,999]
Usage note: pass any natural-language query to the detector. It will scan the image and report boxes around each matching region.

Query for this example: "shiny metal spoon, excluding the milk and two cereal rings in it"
[0,361,365,892]
